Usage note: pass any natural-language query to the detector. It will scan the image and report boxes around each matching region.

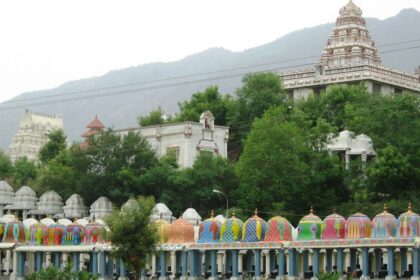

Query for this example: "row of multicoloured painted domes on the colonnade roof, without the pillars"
[0,204,420,246]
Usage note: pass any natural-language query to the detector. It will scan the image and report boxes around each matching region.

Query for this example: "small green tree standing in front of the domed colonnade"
[107,197,159,279]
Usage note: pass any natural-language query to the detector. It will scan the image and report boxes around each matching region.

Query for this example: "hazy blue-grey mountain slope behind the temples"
[0,9,420,149]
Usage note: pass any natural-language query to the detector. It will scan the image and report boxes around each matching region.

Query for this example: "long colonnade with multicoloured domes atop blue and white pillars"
[0,201,420,279]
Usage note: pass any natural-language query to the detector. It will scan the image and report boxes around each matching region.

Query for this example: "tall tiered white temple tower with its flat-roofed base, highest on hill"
[280,0,420,99]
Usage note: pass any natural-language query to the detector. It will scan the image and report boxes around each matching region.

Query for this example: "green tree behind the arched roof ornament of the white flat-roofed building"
[176,86,232,125]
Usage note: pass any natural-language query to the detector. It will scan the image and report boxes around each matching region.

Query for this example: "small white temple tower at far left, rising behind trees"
[7,109,63,162]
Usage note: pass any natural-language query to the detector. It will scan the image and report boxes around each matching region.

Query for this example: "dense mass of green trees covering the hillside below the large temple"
[0,73,420,223]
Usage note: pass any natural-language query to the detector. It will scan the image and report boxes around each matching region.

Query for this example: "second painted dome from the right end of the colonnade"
[372,205,397,238]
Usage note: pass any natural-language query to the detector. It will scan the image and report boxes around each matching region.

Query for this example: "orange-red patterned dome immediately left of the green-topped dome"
[264,216,293,242]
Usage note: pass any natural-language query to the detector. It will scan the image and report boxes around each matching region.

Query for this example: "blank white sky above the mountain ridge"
[0,0,420,102]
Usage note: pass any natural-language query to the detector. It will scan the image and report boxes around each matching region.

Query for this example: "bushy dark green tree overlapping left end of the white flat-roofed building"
[72,130,159,204]
